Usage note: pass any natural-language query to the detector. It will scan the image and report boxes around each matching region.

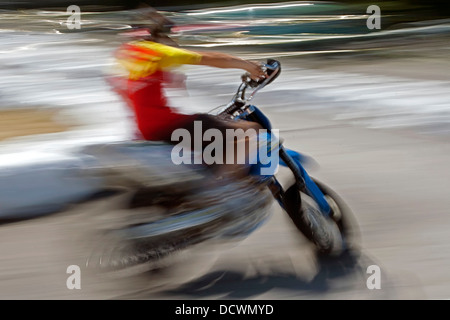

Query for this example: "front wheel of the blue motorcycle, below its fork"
[283,180,357,256]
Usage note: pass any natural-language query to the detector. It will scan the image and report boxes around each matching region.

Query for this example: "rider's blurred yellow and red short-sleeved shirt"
[110,40,202,140]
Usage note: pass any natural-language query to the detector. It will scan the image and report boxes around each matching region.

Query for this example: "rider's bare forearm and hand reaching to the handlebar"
[193,52,264,79]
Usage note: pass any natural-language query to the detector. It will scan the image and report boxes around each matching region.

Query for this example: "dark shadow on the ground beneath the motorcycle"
[115,252,380,299]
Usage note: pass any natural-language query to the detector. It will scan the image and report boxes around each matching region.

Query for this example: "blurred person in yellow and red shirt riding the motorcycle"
[110,10,266,178]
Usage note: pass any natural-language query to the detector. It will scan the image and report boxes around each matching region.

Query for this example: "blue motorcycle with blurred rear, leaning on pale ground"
[82,59,355,271]
